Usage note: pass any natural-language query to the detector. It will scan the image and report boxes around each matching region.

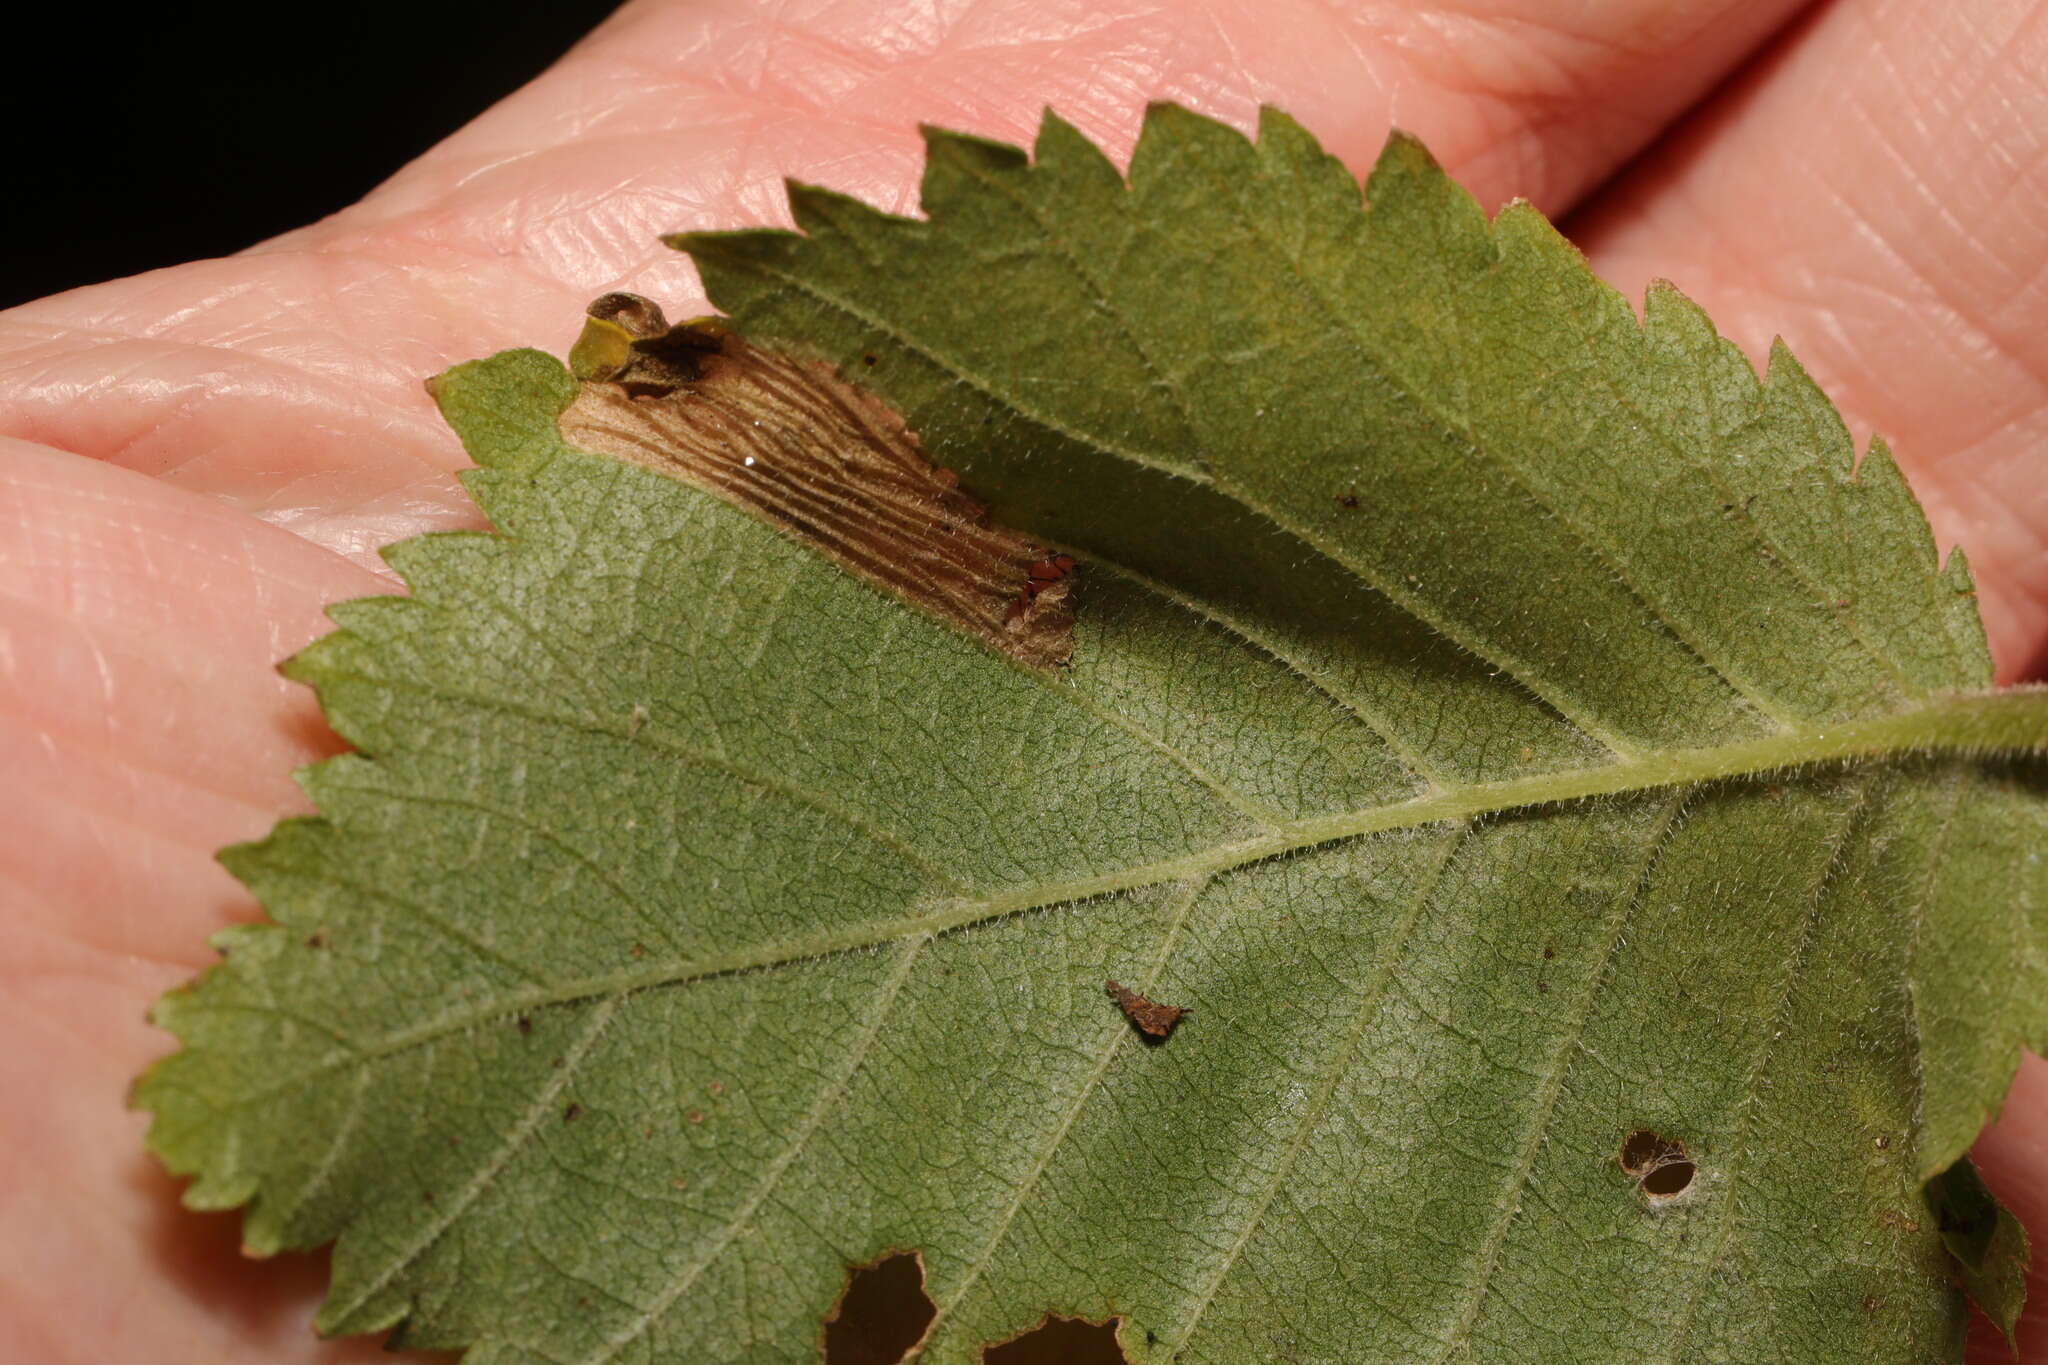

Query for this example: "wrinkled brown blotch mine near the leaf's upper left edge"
[561,295,1075,669]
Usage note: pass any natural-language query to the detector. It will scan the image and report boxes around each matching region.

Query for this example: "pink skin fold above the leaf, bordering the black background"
[0,0,1798,563]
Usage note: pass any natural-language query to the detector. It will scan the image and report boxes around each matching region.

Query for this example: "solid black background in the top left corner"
[0,0,618,307]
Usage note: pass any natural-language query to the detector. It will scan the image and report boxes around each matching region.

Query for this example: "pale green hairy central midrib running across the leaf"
[238,684,2048,1107]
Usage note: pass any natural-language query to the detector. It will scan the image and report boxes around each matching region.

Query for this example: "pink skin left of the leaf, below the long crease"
[0,442,419,1365]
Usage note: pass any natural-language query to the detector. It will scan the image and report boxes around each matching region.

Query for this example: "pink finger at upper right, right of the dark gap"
[1573,0,2048,679]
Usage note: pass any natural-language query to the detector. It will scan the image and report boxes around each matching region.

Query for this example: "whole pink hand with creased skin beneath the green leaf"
[0,0,2048,1365]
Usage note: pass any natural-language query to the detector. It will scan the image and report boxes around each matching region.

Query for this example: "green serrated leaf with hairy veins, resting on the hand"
[139,108,2048,1365]
